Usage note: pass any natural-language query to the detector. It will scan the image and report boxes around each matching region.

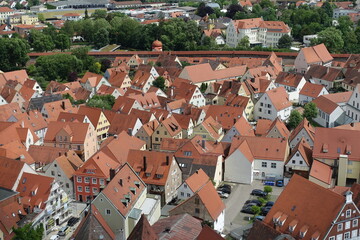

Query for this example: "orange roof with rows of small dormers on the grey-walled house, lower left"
[101,163,146,217]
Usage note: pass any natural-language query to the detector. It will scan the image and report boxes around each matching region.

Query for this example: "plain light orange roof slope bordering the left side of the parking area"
[197,181,225,221]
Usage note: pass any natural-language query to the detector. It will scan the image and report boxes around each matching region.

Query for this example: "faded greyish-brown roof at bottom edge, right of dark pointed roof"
[152,213,202,240]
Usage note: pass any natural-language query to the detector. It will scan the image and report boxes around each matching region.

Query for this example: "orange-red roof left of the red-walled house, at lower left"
[17,172,54,211]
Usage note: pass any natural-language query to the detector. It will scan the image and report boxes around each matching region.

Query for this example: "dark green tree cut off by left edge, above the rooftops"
[0,38,30,72]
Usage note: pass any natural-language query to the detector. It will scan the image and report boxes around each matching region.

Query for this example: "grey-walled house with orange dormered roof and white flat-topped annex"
[93,163,160,239]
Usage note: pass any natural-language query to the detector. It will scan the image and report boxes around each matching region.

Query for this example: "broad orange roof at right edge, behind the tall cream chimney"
[313,127,360,161]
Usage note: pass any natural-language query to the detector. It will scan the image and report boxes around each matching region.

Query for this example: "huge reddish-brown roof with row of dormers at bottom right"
[263,174,345,239]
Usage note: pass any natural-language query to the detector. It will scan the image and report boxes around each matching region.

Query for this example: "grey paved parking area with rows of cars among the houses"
[223,180,284,234]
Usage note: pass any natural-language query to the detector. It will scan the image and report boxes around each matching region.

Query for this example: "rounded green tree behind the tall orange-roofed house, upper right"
[311,27,344,53]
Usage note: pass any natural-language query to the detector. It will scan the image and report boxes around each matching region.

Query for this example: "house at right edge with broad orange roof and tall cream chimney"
[313,128,360,186]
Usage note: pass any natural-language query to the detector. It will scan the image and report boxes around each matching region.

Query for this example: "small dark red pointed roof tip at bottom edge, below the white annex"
[127,214,158,240]
